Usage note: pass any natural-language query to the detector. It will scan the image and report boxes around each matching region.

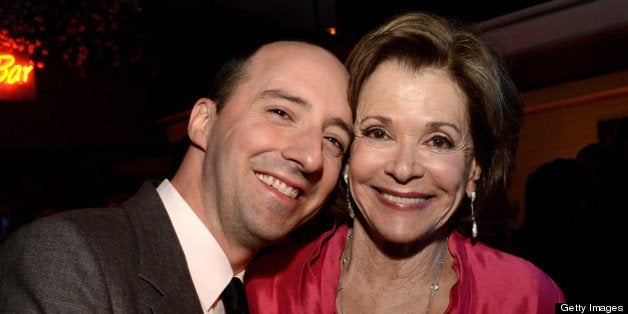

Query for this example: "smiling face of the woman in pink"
[349,61,480,244]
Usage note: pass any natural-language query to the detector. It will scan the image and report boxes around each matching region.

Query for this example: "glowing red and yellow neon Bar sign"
[0,52,36,100]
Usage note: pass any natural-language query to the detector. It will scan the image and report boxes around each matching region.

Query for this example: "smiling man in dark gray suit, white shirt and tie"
[0,41,353,313]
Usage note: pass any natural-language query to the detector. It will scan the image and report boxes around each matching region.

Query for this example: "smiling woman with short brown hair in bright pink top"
[246,12,565,313]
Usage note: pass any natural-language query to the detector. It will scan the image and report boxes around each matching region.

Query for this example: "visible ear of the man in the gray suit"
[188,98,216,150]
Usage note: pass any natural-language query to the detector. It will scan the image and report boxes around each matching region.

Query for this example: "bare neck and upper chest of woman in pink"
[337,223,456,313]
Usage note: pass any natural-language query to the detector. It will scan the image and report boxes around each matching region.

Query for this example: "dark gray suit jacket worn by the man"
[0,181,202,313]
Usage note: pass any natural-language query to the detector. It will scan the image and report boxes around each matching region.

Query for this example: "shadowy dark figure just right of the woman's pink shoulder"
[521,158,602,302]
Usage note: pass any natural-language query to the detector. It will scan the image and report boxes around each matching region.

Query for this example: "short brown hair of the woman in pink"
[345,12,523,237]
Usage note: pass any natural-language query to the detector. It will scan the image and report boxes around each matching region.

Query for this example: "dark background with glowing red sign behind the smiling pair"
[0,0,628,238]
